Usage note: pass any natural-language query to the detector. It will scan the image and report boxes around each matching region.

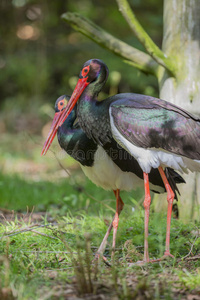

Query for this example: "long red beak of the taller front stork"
[58,77,90,126]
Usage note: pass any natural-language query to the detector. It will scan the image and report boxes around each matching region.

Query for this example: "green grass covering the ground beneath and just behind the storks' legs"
[0,170,200,300]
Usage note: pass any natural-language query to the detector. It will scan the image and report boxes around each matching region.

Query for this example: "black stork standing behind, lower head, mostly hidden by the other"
[42,95,184,260]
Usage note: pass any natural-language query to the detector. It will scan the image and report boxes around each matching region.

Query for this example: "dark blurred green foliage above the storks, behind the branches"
[0,0,162,122]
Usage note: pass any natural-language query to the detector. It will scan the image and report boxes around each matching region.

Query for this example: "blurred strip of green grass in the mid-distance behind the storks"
[0,168,142,215]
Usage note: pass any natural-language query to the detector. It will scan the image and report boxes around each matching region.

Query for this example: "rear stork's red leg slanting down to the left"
[95,190,124,261]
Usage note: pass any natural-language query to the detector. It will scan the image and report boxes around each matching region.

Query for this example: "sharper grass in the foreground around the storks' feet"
[0,198,200,300]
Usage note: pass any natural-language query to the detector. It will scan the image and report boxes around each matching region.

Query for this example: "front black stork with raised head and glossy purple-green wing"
[41,59,200,261]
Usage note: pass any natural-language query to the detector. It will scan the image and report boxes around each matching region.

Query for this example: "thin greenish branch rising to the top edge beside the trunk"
[116,0,176,76]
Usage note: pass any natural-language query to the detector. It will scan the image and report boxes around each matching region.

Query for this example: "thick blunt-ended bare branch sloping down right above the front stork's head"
[62,12,158,75]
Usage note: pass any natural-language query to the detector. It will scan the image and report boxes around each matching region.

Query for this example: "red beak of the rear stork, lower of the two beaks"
[41,112,62,155]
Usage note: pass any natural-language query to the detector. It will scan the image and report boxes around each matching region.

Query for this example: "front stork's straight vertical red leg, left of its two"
[143,173,151,262]
